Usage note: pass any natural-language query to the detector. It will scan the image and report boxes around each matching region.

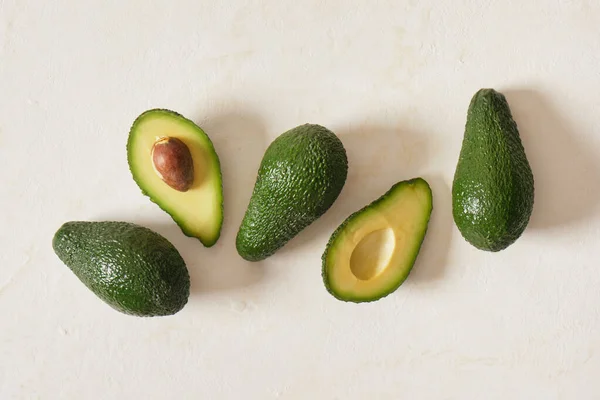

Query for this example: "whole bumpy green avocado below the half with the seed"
[52,221,190,317]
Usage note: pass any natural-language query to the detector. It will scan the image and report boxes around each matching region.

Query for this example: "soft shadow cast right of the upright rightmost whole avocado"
[503,89,600,229]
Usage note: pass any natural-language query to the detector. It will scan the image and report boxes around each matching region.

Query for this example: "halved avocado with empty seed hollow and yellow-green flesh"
[322,178,433,303]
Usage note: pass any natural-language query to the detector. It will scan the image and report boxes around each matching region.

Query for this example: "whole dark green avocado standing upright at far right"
[452,89,534,252]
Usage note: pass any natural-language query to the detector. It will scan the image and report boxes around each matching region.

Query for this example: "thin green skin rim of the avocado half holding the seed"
[126,108,224,247]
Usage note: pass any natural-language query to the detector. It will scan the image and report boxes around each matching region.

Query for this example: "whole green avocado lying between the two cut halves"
[236,124,348,261]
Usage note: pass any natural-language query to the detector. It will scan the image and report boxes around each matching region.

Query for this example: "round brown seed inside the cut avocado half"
[152,137,194,192]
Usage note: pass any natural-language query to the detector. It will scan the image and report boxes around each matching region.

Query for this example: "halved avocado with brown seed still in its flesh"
[127,109,223,247]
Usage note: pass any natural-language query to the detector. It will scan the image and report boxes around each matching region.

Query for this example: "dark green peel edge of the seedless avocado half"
[321,177,433,303]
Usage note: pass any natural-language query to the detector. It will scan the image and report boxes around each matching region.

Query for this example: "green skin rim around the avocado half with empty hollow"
[321,178,433,303]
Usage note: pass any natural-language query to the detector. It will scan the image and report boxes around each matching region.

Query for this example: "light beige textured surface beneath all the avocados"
[0,0,600,400]
